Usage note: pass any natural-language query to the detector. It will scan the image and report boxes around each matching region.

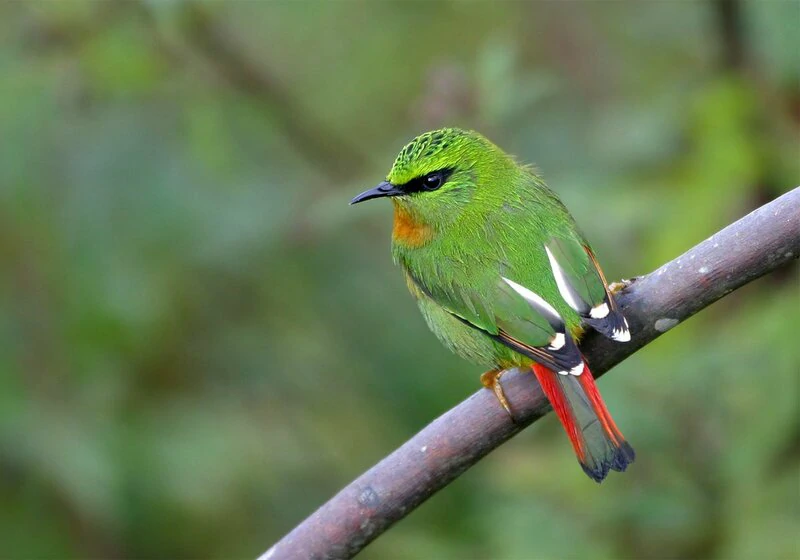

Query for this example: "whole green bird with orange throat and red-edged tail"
[351,128,635,482]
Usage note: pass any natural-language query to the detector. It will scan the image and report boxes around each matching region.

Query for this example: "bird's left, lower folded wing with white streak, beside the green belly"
[407,271,583,375]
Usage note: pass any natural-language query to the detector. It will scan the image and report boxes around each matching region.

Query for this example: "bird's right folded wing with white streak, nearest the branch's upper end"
[545,237,631,342]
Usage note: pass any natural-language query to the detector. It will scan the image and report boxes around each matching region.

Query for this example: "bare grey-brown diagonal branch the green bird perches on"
[261,187,800,560]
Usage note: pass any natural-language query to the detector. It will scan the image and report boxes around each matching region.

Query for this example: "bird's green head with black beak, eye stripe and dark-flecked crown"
[351,128,514,227]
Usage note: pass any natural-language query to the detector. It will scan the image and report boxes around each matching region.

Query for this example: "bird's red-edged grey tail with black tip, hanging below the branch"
[532,364,636,482]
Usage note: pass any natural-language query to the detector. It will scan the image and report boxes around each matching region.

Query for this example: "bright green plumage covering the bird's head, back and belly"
[387,129,603,367]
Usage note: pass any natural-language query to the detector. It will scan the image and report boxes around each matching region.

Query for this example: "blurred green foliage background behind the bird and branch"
[0,1,800,559]
